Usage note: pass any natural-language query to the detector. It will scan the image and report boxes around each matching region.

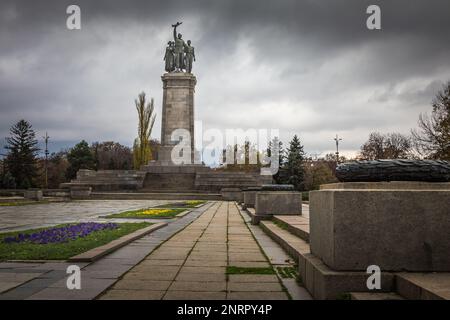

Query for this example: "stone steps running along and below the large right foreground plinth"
[243,208,450,300]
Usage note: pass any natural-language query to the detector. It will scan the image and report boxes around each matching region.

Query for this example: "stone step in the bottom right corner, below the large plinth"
[396,272,450,300]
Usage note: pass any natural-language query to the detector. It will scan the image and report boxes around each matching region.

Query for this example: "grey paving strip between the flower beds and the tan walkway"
[0,201,212,300]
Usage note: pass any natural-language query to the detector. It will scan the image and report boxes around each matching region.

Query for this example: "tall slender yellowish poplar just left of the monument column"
[133,92,156,169]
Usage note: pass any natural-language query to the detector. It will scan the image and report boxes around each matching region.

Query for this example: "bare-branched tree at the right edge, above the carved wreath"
[411,81,450,160]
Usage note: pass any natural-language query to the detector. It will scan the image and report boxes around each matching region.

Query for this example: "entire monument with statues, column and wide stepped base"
[62,22,272,198]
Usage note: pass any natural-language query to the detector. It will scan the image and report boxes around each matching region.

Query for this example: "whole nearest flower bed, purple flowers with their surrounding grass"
[0,222,151,261]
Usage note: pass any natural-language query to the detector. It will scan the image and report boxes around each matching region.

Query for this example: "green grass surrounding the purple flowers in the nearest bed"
[0,222,151,261]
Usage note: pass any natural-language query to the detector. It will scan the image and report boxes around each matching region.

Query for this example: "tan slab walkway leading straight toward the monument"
[100,202,288,299]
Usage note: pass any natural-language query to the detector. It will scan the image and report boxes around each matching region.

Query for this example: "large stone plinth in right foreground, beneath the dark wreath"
[310,182,450,271]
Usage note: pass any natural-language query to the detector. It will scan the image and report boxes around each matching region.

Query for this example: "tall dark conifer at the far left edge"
[5,120,39,189]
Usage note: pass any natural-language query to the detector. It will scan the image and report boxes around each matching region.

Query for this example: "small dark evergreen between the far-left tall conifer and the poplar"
[66,140,95,179]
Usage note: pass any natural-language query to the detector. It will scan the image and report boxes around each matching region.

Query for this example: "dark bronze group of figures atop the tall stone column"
[164,22,195,73]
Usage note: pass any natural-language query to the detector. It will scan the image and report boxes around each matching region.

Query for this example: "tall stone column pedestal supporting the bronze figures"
[158,72,197,164]
